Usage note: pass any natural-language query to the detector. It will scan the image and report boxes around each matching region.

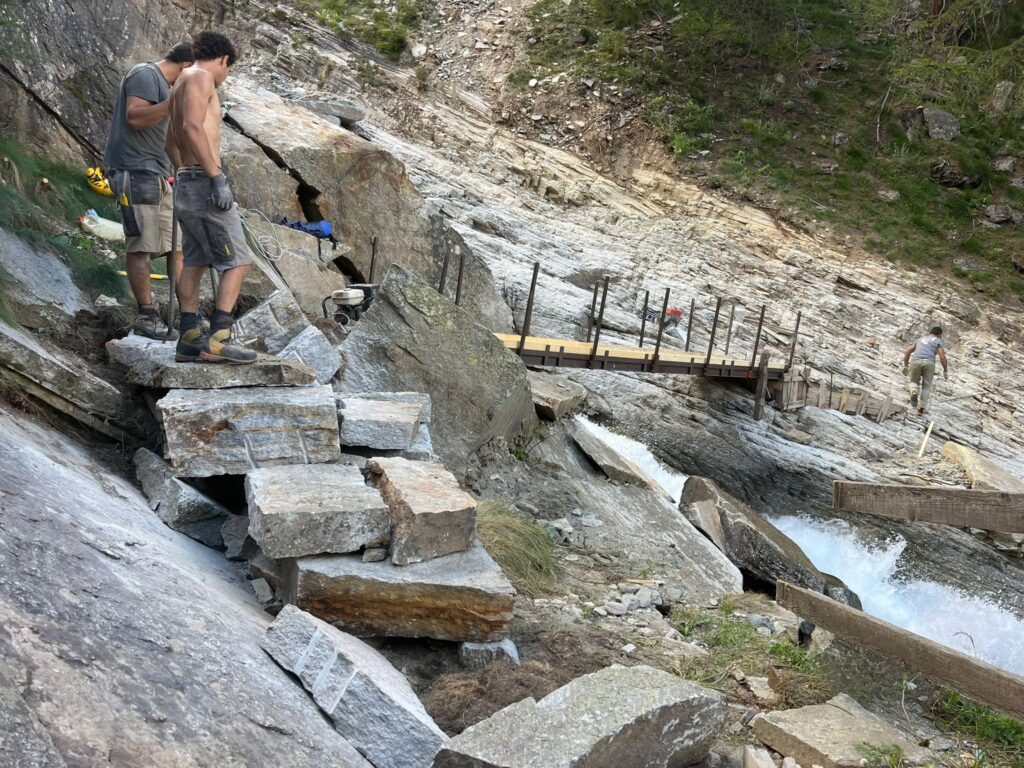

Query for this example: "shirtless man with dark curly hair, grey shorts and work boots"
[168,32,256,362]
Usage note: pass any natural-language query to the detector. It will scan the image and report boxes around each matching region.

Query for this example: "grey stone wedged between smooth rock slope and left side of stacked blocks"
[134,449,230,548]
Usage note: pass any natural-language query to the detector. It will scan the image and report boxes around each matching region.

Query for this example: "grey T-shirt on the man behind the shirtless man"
[103,61,171,176]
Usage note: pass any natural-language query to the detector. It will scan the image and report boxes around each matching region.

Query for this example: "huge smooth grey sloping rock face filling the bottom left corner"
[0,413,370,768]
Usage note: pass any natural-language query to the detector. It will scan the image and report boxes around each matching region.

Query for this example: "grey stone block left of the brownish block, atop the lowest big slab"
[246,464,391,558]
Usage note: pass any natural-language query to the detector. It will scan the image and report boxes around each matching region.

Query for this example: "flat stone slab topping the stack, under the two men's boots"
[106,334,316,389]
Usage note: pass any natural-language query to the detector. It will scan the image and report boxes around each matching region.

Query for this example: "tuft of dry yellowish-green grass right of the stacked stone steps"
[476,501,557,597]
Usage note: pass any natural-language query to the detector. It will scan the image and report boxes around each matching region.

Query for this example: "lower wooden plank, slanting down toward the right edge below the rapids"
[775,582,1024,719]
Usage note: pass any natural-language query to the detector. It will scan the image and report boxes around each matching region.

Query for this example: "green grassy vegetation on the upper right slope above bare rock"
[514,0,1024,298]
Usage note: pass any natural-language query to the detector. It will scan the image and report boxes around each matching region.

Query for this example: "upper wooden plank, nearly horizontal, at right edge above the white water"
[833,480,1024,534]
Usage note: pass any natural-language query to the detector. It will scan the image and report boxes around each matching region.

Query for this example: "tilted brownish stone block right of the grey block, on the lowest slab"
[367,458,476,565]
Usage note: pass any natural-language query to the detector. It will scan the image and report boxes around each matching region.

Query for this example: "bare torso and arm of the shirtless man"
[169,67,221,176]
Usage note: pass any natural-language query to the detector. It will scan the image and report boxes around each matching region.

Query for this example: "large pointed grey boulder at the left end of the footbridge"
[338,266,537,466]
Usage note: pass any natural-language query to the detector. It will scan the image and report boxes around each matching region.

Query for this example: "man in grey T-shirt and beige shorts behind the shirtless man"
[103,43,194,339]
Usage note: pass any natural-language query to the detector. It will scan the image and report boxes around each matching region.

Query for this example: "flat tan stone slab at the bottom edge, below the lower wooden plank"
[751,693,935,768]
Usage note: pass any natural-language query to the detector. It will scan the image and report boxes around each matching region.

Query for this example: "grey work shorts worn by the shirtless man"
[174,168,253,272]
